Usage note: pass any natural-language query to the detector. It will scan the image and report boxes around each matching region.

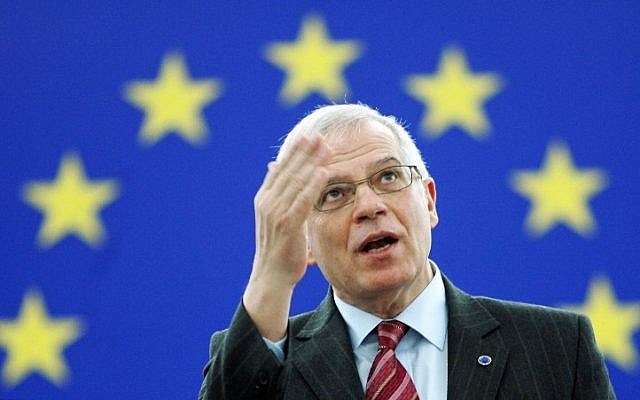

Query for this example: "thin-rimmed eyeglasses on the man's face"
[314,165,422,212]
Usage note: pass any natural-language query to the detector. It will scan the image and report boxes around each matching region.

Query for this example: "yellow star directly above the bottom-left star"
[23,153,118,248]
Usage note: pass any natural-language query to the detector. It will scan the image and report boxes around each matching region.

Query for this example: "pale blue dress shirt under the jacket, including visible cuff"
[263,260,448,400]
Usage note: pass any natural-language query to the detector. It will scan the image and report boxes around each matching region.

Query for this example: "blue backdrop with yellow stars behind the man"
[0,1,640,400]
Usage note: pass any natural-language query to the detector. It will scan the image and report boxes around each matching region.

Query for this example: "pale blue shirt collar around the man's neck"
[333,260,447,350]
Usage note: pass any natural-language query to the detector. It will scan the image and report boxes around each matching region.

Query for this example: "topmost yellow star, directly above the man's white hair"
[266,17,361,105]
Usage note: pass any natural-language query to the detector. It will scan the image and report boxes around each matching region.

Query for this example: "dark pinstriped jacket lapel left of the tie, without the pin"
[289,291,364,399]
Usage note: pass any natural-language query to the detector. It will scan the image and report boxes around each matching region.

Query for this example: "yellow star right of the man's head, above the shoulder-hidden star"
[511,143,606,236]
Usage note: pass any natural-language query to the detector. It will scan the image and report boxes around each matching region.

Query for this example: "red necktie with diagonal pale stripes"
[365,320,418,400]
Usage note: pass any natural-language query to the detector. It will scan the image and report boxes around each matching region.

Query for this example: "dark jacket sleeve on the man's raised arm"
[198,303,282,400]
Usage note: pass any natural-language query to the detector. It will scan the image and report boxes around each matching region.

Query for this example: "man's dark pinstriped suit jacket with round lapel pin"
[199,277,615,400]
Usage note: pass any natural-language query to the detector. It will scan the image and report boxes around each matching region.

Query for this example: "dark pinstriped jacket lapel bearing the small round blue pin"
[443,276,509,399]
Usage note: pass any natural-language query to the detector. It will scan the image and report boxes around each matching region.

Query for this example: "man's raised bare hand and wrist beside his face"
[243,134,331,341]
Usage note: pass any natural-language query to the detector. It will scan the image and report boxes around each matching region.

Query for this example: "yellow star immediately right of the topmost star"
[405,48,501,139]
